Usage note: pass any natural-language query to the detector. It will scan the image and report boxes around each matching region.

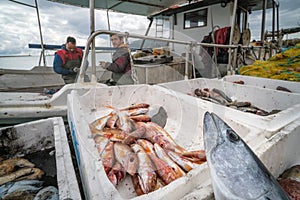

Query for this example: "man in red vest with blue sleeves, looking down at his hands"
[53,36,83,84]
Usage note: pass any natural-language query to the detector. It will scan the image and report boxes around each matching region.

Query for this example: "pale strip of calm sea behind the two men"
[0,53,111,70]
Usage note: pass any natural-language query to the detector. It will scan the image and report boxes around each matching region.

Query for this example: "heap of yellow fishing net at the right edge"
[238,43,300,82]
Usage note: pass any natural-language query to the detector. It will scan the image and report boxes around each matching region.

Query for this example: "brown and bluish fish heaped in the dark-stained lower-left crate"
[0,158,58,200]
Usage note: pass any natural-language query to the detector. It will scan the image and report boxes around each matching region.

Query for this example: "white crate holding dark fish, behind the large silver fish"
[159,78,300,132]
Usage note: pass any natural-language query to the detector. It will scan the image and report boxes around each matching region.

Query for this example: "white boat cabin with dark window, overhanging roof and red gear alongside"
[47,0,279,80]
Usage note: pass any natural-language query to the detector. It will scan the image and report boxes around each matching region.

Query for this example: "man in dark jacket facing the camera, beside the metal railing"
[99,34,134,85]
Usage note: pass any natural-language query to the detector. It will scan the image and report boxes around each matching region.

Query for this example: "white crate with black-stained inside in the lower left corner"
[0,117,81,200]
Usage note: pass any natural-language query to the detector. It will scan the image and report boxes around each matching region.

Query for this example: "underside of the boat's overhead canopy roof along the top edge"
[48,0,278,17]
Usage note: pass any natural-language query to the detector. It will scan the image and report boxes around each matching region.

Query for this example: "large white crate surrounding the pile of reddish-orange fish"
[68,85,266,200]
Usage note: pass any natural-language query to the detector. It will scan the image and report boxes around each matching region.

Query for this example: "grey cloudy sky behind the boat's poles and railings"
[0,0,300,55]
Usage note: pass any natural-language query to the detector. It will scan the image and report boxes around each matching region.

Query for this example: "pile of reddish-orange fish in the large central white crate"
[89,103,206,196]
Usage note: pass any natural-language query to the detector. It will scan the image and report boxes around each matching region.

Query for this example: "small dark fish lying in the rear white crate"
[194,88,280,116]
